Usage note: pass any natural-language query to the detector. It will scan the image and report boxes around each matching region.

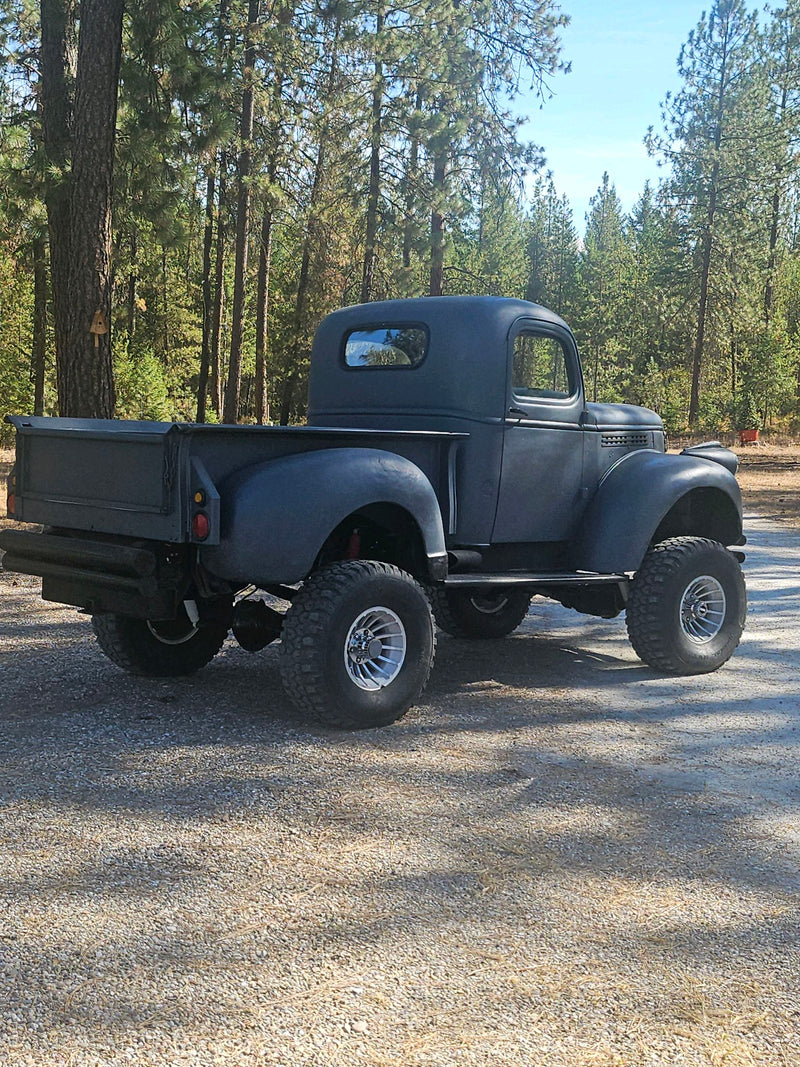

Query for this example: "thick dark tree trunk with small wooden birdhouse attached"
[59,0,124,418]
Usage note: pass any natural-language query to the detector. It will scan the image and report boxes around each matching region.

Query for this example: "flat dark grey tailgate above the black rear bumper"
[9,416,185,541]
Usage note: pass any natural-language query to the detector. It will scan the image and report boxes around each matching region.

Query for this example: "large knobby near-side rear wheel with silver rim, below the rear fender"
[281,559,435,730]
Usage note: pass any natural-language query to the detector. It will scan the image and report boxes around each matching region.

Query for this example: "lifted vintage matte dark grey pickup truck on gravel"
[0,297,747,728]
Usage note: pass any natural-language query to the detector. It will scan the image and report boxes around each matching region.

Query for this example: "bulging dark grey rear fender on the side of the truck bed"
[199,448,447,586]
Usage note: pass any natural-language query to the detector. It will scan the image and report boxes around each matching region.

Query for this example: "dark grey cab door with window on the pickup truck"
[492,319,583,543]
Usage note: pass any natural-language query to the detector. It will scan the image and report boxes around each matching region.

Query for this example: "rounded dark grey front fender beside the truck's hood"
[572,450,741,574]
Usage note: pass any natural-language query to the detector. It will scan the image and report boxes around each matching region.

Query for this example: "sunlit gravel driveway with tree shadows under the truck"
[0,519,800,1067]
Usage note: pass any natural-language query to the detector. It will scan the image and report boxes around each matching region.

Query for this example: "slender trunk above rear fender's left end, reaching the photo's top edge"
[222,0,260,423]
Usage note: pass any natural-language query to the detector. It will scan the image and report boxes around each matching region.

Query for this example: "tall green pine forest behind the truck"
[0,0,800,440]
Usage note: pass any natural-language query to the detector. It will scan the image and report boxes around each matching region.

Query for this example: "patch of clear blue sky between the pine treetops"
[519,0,709,227]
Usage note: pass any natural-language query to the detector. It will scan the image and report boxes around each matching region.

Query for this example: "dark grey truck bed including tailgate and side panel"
[9,416,464,544]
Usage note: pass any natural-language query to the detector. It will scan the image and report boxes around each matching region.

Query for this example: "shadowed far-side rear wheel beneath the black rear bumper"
[92,604,228,678]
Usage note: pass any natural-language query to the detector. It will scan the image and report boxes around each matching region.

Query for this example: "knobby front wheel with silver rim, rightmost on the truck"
[627,537,747,674]
